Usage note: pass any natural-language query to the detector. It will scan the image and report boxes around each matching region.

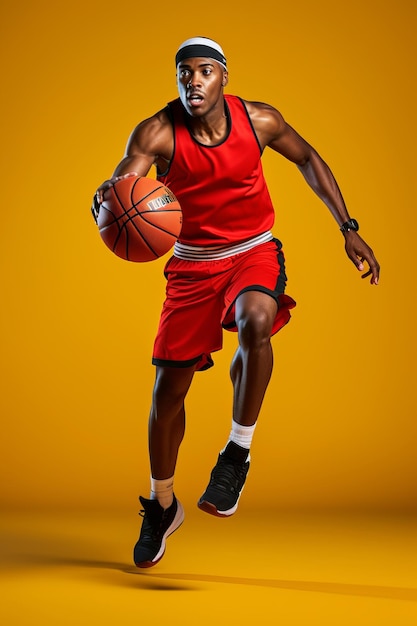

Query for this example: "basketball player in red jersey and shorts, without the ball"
[93,37,379,567]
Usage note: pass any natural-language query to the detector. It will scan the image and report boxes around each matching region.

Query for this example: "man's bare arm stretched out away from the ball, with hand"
[246,102,379,285]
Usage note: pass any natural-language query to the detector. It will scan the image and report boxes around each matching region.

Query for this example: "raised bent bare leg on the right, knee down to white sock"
[230,291,277,426]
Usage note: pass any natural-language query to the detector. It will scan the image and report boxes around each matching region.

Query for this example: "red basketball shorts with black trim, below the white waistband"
[152,239,295,370]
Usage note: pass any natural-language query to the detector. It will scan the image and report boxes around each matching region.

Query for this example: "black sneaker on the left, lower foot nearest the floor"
[133,496,184,567]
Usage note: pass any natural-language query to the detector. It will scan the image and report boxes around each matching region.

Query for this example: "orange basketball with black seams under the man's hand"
[97,176,182,263]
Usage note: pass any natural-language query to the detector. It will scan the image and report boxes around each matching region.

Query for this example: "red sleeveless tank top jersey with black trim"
[158,95,274,246]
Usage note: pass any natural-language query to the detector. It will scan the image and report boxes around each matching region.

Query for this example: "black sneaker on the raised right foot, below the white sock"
[198,443,249,517]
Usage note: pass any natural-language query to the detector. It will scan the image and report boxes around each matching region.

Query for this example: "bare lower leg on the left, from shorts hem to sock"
[149,367,194,480]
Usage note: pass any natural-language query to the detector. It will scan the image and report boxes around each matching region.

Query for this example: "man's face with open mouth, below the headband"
[177,57,228,117]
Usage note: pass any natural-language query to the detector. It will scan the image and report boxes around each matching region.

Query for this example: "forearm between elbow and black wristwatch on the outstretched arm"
[297,150,350,226]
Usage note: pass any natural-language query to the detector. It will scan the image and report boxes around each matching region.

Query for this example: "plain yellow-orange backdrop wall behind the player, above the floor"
[0,0,417,510]
